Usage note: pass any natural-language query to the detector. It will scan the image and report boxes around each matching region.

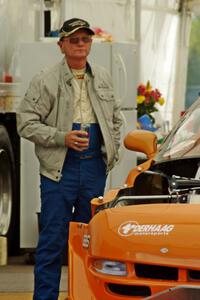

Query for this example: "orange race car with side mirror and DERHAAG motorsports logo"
[68,99,200,300]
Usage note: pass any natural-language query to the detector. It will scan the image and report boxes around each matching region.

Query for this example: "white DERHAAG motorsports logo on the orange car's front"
[118,221,174,236]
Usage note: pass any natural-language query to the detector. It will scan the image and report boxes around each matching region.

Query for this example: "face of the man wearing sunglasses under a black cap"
[58,29,92,59]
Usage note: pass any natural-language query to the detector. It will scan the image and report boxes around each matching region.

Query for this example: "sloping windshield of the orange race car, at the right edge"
[155,98,200,162]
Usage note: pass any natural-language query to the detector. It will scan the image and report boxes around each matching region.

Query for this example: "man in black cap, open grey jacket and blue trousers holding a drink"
[17,18,121,300]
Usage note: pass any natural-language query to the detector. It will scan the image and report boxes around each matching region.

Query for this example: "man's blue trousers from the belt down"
[33,155,106,300]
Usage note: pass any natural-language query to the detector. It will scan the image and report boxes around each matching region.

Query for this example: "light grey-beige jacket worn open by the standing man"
[17,59,122,181]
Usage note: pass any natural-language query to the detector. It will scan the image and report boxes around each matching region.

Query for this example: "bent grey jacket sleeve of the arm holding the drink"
[17,75,66,147]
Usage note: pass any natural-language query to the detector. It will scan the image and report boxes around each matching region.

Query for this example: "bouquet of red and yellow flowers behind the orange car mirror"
[137,81,165,124]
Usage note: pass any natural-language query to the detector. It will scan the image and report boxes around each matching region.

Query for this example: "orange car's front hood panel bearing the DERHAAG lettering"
[88,204,200,268]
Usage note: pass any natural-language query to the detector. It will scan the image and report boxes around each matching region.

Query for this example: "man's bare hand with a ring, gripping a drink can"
[65,130,89,152]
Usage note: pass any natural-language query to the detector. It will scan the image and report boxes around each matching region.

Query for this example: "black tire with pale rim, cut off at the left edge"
[0,125,18,254]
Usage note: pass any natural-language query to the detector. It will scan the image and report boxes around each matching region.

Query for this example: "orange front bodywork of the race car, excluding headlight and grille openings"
[69,204,200,300]
